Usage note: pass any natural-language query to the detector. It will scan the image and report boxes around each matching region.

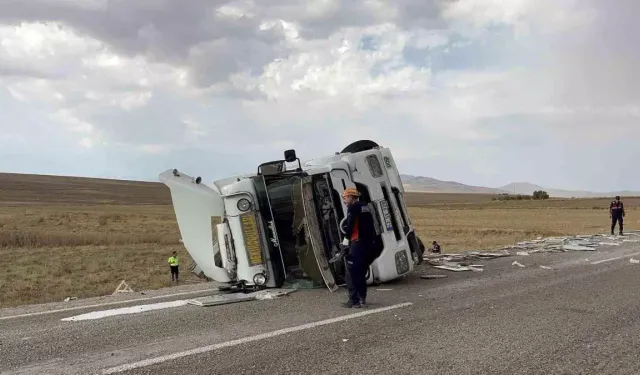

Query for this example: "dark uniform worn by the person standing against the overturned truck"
[345,201,376,307]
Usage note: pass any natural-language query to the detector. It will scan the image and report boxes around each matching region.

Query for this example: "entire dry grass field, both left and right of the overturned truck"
[0,173,640,307]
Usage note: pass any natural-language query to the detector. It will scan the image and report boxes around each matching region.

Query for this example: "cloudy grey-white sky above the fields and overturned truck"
[0,0,640,191]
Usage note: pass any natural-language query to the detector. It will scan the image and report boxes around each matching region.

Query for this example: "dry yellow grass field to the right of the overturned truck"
[407,193,640,252]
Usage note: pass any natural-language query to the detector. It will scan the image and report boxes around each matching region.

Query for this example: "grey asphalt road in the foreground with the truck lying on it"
[0,239,640,375]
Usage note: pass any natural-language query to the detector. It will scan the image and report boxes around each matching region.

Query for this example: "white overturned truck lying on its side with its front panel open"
[159,140,424,291]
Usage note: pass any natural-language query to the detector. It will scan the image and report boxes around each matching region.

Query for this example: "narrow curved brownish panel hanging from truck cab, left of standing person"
[302,177,338,292]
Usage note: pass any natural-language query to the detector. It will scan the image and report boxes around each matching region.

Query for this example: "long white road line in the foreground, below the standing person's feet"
[102,302,413,374]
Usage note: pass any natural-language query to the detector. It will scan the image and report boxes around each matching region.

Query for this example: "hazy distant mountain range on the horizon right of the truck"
[400,175,640,198]
